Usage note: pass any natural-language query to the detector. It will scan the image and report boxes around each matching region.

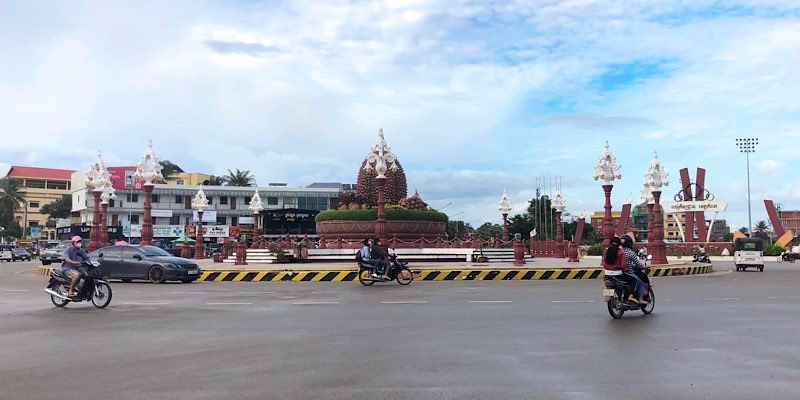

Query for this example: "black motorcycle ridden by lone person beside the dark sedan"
[44,261,111,308]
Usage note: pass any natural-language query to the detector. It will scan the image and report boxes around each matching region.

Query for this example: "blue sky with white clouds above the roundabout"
[0,0,800,228]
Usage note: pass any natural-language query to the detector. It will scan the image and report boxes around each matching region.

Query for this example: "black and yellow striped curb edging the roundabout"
[39,264,714,282]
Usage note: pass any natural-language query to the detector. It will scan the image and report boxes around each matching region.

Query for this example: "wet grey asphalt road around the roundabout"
[0,263,800,400]
